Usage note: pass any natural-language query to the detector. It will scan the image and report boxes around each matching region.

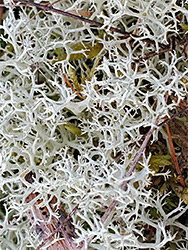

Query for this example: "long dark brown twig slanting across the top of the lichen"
[14,0,169,49]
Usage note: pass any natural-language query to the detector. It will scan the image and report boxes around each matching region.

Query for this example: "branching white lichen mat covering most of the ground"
[0,0,188,250]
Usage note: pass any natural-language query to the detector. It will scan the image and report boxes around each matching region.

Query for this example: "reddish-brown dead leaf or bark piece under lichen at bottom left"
[25,172,83,250]
